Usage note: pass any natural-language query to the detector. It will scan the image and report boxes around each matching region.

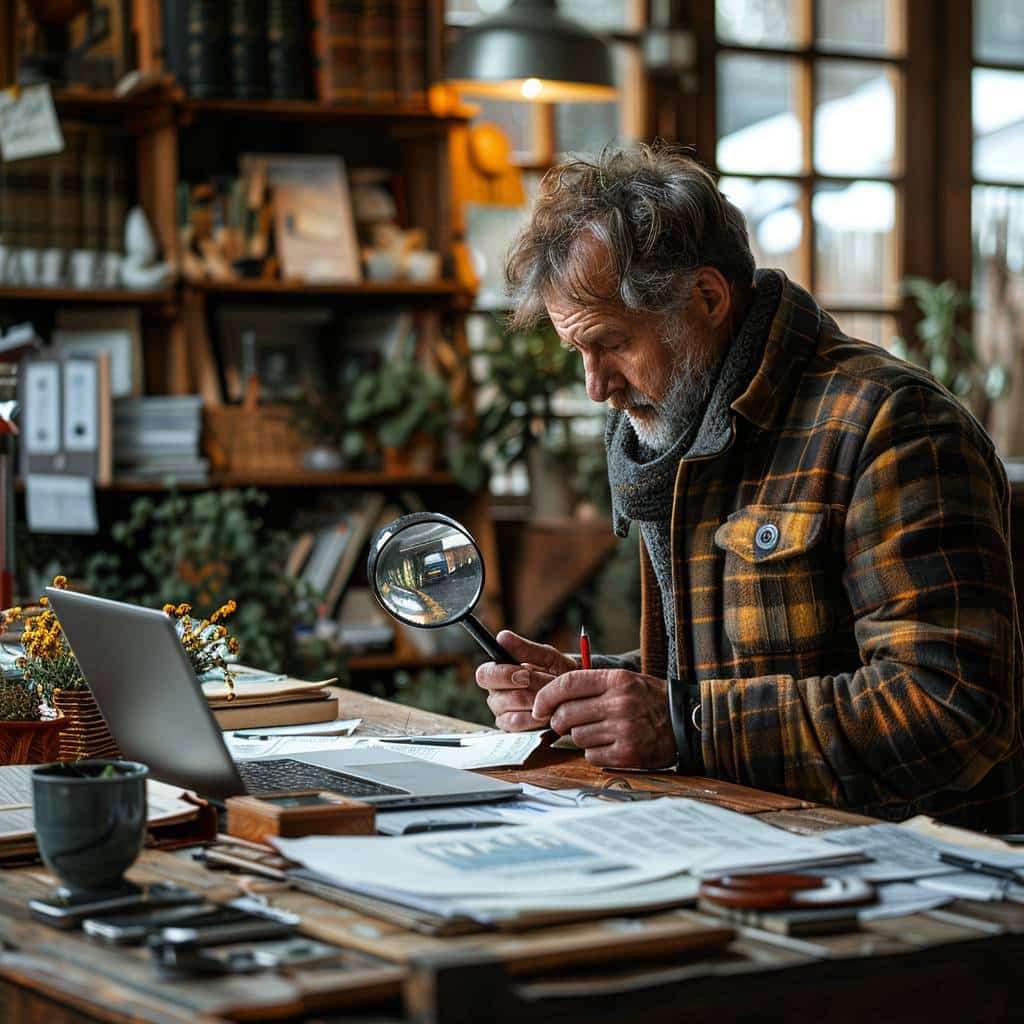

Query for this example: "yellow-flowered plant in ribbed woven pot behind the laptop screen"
[4,575,110,761]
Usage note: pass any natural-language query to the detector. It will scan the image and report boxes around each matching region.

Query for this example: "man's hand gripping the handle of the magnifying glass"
[476,630,579,732]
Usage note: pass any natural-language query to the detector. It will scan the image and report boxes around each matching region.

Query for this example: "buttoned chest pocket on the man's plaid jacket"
[715,502,833,654]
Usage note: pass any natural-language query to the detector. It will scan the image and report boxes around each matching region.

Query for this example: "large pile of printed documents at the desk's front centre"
[274,798,860,927]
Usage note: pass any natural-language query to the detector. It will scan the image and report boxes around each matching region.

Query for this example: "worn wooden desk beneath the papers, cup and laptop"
[0,690,1024,1024]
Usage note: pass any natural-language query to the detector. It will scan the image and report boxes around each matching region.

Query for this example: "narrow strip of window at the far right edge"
[971,0,1024,436]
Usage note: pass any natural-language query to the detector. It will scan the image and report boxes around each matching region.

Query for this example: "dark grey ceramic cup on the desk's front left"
[32,761,150,892]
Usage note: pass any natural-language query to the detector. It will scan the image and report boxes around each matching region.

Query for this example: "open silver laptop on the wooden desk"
[46,587,521,808]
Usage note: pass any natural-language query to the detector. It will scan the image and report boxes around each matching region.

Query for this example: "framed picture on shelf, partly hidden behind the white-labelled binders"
[51,309,144,398]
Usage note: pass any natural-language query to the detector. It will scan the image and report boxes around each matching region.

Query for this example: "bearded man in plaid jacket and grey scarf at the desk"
[477,147,1024,831]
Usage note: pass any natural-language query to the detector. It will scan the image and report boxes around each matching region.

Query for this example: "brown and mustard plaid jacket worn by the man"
[641,282,1024,831]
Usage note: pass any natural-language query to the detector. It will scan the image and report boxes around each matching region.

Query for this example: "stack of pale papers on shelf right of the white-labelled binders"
[114,394,210,483]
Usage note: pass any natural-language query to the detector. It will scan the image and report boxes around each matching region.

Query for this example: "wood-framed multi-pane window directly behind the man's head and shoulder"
[714,0,905,344]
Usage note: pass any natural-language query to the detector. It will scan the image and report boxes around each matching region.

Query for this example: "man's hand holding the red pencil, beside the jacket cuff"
[531,669,676,768]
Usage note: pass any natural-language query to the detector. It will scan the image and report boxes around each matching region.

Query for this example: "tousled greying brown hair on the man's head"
[505,144,754,327]
